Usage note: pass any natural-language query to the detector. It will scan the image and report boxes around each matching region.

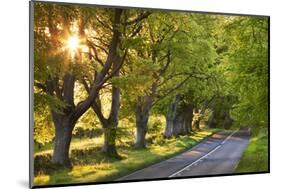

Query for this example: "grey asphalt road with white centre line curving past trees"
[117,130,249,181]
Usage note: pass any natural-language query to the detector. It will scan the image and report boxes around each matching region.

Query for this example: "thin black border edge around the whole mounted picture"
[28,0,271,188]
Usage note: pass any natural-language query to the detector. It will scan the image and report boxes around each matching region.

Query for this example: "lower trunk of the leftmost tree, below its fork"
[52,117,74,167]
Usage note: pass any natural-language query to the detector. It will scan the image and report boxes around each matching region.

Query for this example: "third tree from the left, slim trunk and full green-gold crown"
[110,13,218,148]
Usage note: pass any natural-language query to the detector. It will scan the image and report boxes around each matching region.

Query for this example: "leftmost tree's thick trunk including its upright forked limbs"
[46,73,76,167]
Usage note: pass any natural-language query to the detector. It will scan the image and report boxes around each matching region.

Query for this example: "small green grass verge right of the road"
[235,129,268,173]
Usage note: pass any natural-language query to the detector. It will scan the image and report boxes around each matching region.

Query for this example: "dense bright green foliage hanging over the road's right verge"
[222,17,268,126]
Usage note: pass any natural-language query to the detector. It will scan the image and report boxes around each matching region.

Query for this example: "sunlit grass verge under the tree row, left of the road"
[34,130,214,185]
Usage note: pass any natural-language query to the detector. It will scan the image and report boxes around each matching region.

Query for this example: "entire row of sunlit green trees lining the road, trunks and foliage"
[34,3,268,166]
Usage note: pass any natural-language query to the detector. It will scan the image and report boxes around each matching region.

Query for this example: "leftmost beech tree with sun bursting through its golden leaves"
[34,3,127,166]
